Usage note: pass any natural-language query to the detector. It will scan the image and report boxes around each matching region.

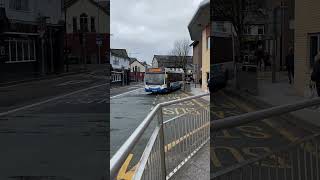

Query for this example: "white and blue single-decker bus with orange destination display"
[144,68,184,93]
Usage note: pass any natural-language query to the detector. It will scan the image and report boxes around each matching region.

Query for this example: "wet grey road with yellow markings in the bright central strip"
[110,89,208,180]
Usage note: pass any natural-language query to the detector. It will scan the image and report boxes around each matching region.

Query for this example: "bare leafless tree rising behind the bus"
[170,39,191,72]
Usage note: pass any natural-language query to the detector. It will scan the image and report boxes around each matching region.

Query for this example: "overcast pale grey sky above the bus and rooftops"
[110,0,202,63]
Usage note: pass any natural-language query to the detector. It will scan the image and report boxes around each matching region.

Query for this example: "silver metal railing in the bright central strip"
[110,93,210,180]
